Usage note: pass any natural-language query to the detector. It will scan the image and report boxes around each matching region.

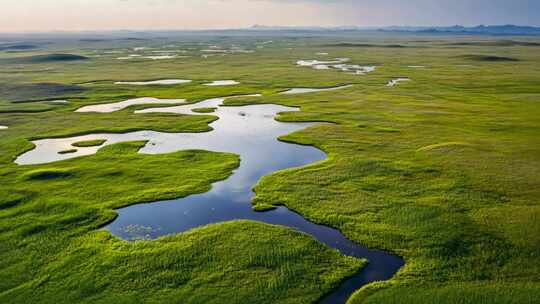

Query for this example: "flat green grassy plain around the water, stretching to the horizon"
[0,33,540,303]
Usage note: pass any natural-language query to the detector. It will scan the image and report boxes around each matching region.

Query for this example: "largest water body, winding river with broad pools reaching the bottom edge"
[16,94,404,303]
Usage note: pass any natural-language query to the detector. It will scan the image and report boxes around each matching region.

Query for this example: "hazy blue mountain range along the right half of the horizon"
[249,24,540,35]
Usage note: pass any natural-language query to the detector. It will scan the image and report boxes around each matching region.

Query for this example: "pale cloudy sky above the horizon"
[0,0,540,32]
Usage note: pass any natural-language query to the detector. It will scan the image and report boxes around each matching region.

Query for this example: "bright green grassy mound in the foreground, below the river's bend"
[0,221,359,303]
